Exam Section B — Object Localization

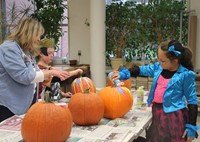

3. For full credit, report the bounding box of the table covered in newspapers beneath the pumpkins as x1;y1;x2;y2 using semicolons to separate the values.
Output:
0;90;152;142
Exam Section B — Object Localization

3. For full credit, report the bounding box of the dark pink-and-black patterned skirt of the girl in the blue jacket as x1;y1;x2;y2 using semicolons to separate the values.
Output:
147;103;188;142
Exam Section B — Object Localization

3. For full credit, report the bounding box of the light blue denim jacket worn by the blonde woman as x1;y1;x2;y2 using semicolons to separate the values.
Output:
0;41;38;115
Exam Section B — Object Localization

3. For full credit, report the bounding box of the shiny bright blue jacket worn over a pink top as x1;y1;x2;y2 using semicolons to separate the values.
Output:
139;63;198;113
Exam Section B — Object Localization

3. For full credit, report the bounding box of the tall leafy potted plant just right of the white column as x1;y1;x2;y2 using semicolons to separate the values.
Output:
106;2;137;68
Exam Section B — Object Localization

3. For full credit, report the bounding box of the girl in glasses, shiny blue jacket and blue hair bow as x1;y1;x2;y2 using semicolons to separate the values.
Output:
110;40;200;142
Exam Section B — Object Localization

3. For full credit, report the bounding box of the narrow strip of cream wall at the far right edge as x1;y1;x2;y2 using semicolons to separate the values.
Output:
189;0;200;70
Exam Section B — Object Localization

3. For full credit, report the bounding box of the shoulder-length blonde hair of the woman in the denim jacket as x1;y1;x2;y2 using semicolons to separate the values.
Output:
7;17;44;55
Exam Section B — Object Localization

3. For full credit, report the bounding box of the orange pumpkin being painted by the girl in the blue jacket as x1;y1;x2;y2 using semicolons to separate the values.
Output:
98;86;133;119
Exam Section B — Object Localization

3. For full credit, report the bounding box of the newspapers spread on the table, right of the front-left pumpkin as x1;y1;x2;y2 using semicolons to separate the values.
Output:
67;107;151;142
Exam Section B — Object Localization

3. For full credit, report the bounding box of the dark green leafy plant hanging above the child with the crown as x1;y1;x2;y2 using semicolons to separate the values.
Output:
31;0;67;50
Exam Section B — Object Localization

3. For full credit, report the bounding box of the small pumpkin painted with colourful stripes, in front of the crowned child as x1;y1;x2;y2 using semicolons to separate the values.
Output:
71;77;96;94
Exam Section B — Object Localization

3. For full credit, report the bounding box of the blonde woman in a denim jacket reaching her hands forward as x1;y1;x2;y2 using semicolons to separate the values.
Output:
0;17;69;122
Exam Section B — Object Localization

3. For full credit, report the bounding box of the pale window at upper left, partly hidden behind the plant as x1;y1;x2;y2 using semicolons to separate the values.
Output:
1;0;68;57
